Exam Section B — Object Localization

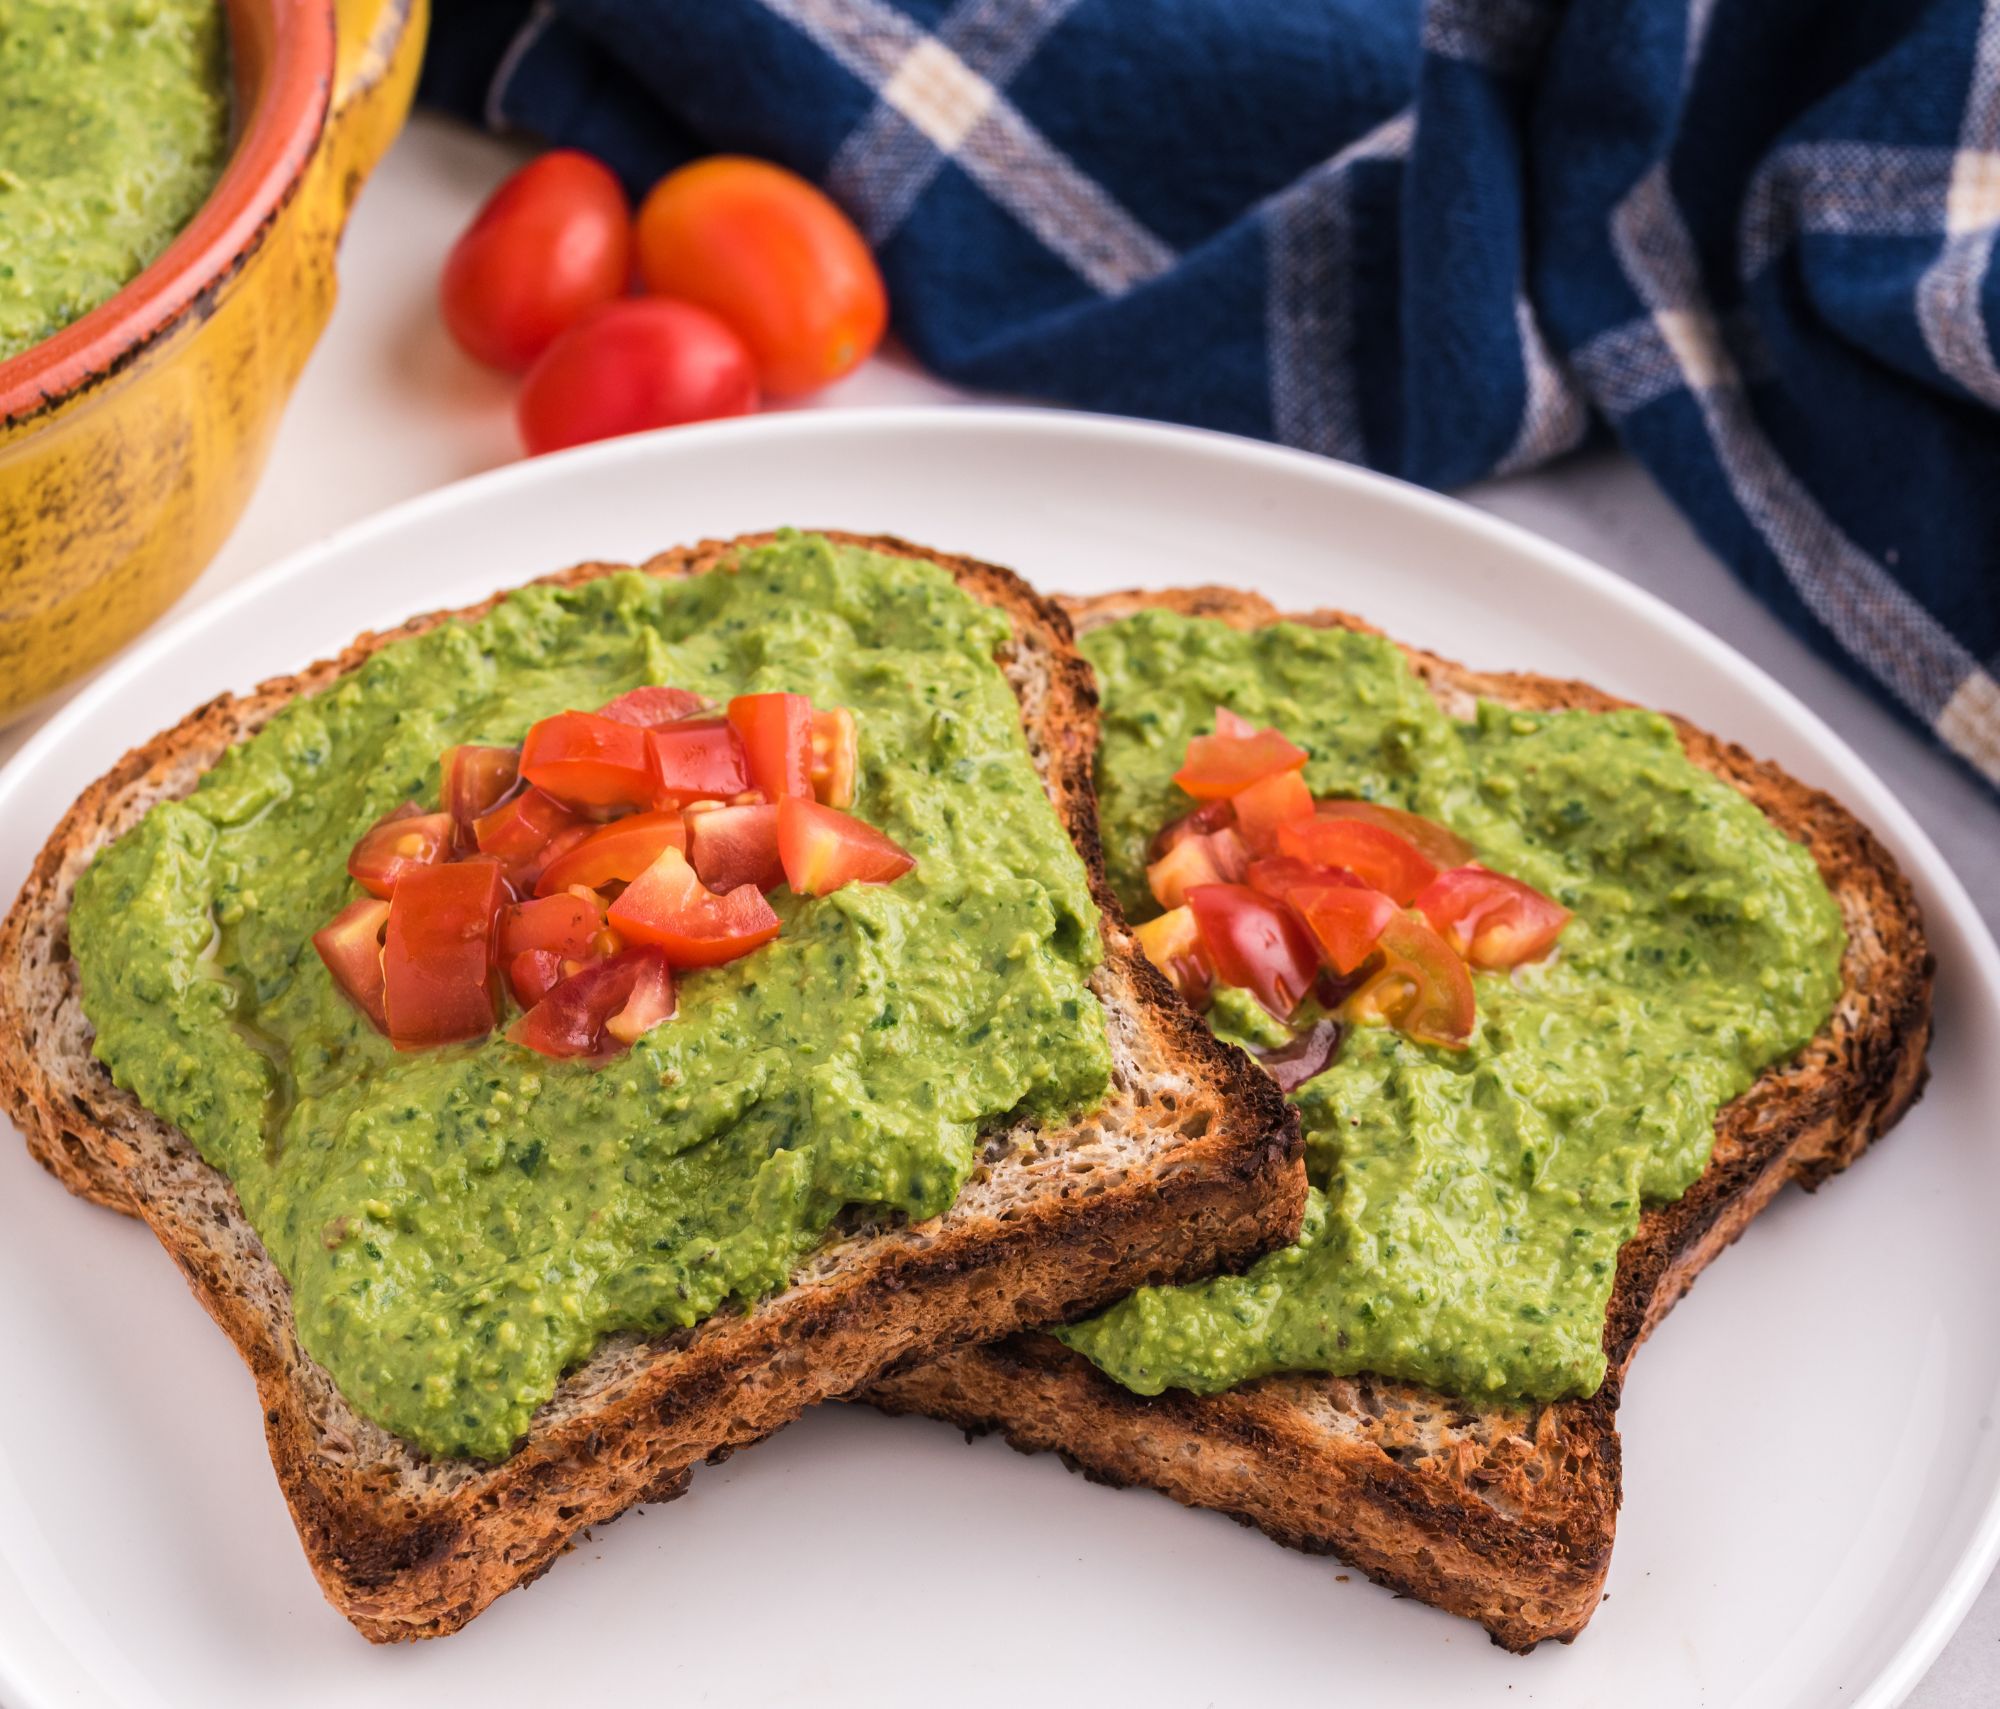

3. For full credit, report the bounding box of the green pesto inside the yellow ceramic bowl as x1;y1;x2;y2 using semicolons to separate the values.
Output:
0;0;230;360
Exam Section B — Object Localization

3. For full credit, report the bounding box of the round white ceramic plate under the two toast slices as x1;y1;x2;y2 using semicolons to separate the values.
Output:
0;410;2000;1709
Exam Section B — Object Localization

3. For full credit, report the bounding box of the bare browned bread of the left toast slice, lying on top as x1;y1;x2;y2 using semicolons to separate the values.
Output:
0;536;1304;1641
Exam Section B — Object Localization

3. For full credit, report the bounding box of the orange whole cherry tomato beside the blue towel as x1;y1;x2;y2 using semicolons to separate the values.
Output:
638;154;888;398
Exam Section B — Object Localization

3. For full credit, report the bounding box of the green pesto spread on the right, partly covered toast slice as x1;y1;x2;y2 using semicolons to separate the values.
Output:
1060;612;1846;1401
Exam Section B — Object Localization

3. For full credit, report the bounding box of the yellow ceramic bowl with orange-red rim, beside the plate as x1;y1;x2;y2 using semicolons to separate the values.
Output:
0;0;428;722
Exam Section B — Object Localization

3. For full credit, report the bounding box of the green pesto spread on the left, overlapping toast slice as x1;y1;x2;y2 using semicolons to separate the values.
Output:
70;538;1110;1459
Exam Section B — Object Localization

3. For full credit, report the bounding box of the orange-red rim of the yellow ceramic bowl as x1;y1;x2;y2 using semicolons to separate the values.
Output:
0;0;334;428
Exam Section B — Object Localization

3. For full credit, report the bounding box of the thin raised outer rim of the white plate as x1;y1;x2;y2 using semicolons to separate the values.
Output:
0;402;2000;1709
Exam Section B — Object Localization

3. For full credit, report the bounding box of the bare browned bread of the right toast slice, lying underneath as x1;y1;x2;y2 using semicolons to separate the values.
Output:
860;588;1932;1651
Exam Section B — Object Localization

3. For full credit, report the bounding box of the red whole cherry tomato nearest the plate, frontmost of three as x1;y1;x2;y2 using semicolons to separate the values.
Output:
514;296;758;456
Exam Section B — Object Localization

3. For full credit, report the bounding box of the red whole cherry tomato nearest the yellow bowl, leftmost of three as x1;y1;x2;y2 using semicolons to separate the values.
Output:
438;148;632;372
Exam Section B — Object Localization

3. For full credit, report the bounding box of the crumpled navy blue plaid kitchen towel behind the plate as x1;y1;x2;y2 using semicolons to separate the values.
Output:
426;0;2000;784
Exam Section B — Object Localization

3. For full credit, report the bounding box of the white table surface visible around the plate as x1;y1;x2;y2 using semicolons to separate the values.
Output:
0;116;2000;1709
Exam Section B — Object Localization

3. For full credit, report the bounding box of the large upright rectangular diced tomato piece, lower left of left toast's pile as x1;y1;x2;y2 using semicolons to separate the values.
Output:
382;861;506;1051
